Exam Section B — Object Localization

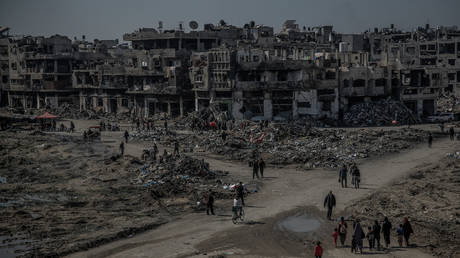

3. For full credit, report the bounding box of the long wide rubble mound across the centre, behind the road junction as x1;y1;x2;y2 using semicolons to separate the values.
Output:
168;121;426;168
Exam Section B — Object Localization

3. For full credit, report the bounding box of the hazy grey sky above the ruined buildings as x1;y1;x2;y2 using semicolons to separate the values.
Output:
0;0;460;39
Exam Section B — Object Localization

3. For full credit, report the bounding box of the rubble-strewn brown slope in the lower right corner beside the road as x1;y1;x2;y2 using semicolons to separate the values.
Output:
347;152;460;257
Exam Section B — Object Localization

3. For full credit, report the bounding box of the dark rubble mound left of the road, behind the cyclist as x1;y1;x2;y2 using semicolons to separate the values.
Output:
133;155;232;201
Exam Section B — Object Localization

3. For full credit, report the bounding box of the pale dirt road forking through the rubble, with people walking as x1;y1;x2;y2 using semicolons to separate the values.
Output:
65;127;454;257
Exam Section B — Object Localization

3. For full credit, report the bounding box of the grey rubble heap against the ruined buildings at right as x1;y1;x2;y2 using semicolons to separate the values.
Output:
343;99;420;126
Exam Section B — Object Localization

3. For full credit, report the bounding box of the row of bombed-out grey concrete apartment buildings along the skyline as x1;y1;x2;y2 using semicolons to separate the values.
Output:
0;20;460;120
